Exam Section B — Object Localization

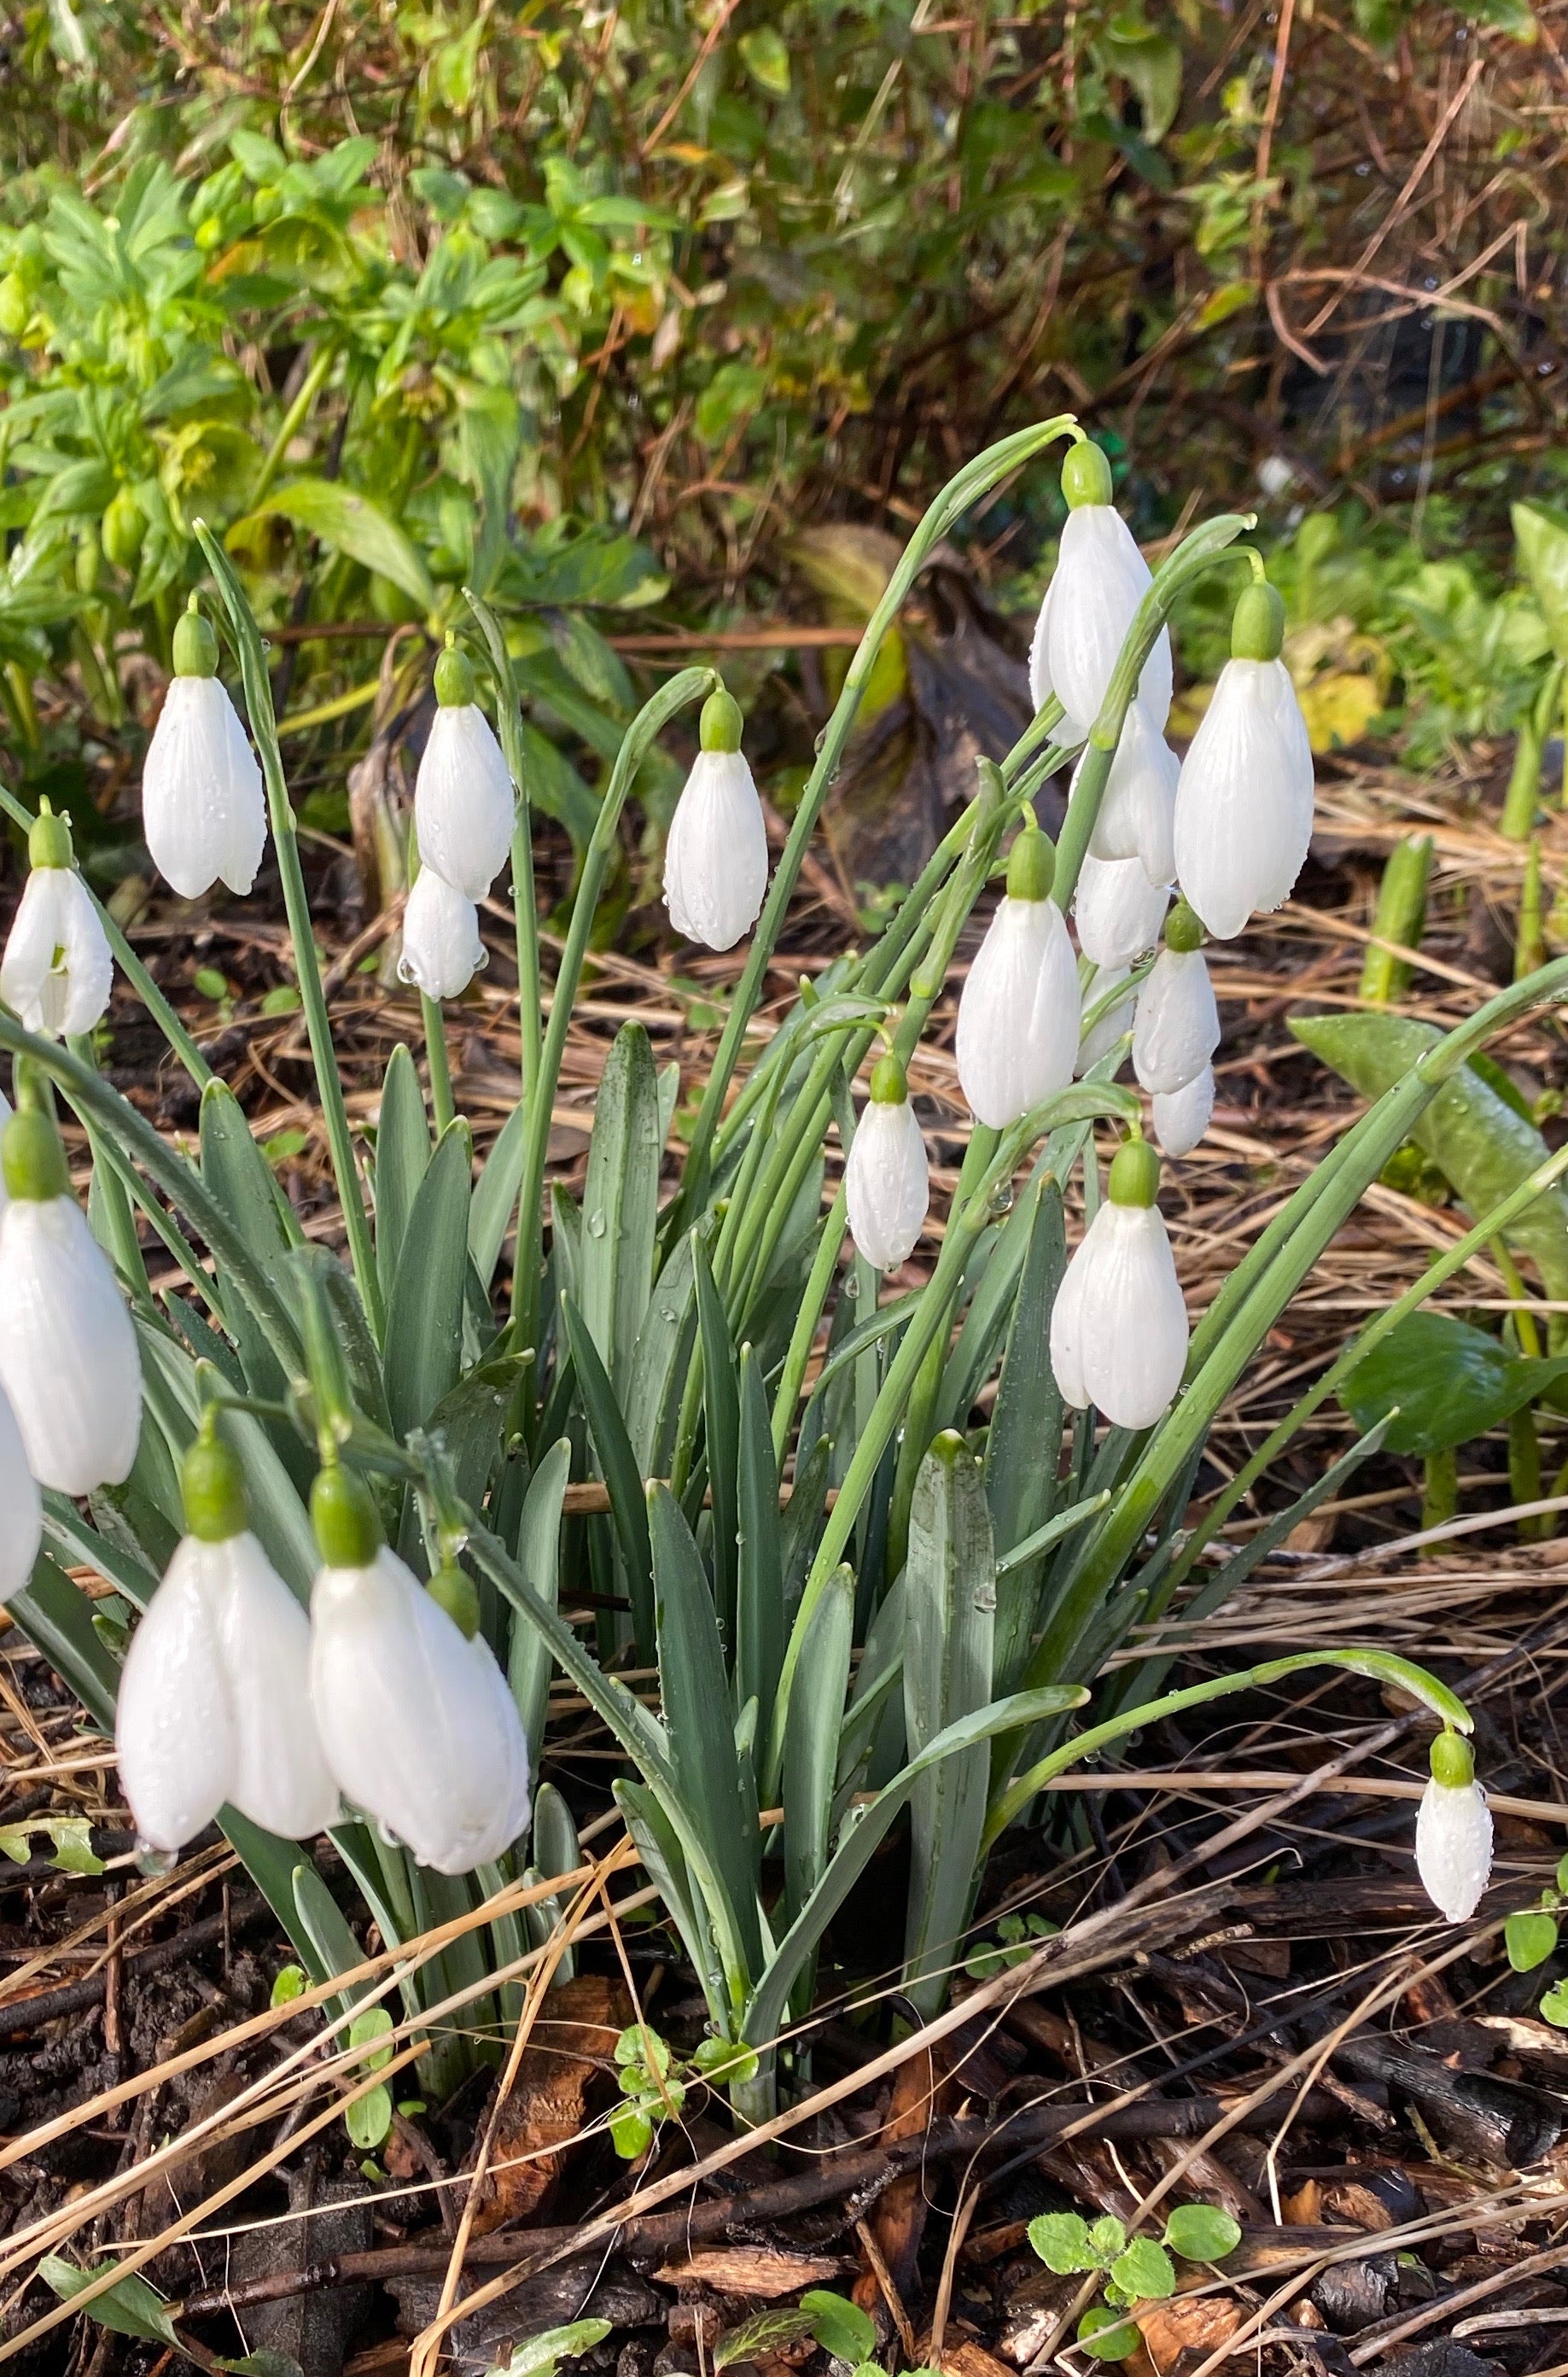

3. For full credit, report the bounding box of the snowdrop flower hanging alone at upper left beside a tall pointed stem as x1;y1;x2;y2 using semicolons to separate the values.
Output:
143;594;266;898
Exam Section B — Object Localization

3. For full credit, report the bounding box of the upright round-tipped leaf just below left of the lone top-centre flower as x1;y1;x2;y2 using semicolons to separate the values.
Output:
577;1022;663;1393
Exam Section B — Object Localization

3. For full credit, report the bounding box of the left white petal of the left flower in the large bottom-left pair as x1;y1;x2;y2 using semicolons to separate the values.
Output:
114;1538;236;1849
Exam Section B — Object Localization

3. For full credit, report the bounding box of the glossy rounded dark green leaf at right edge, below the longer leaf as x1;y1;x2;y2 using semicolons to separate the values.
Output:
1340;1312;1568;1455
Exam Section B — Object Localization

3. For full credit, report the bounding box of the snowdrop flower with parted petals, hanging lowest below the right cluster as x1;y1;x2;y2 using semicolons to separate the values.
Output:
1050;1139;1188;1428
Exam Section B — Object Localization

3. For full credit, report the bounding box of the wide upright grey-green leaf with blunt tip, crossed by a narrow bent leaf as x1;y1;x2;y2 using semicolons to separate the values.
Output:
898;1428;995;2013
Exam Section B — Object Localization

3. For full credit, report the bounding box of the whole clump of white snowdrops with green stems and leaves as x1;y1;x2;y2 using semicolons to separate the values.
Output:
0;416;1520;2116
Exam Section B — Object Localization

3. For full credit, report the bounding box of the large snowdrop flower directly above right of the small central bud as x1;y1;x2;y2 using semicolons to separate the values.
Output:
955;820;1081;1129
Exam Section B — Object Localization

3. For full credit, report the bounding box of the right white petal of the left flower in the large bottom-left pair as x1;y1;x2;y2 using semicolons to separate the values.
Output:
202;1533;337;1840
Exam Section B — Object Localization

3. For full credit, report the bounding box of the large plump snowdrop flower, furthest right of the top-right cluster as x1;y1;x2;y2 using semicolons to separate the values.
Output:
1176;580;1311;941
